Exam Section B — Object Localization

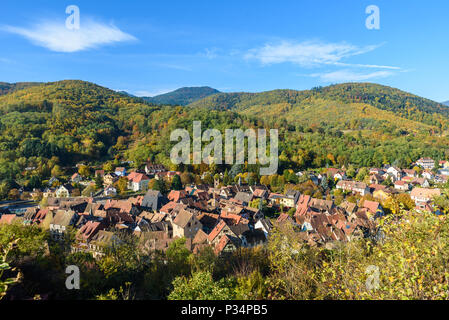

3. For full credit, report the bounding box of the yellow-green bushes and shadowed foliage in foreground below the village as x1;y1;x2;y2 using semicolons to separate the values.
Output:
0;211;449;300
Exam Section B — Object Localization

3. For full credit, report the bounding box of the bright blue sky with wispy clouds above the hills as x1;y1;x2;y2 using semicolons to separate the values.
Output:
0;0;449;101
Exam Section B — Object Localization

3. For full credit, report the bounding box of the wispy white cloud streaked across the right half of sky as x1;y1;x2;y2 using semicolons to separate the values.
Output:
245;41;398;69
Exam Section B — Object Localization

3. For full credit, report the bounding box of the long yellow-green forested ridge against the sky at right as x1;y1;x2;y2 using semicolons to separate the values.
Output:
190;83;449;128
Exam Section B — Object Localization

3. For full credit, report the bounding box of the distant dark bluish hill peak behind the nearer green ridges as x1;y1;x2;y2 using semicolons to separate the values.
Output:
143;87;220;106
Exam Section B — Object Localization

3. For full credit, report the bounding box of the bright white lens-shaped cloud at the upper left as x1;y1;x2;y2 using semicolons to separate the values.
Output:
2;19;136;52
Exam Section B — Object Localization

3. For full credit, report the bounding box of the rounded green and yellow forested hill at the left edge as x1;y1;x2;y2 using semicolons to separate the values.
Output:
0;80;160;168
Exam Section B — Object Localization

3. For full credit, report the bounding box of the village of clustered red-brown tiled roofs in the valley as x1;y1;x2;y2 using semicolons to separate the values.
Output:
0;158;449;258
